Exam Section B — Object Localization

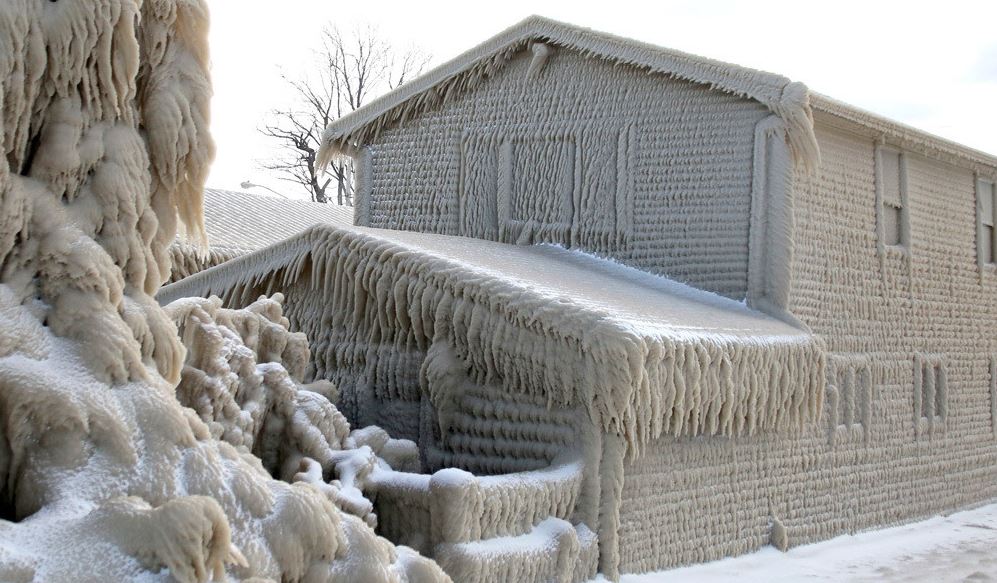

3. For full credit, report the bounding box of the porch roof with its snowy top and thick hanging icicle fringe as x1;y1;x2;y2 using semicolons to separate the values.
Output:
157;226;824;449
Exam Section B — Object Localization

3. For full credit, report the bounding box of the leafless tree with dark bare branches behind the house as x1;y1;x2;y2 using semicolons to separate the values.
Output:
260;26;430;204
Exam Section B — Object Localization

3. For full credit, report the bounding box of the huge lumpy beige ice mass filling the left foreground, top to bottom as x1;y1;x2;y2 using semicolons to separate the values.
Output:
0;0;445;581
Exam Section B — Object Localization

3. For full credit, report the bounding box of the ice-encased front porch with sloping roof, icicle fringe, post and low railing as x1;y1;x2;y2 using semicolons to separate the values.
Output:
159;222;824;581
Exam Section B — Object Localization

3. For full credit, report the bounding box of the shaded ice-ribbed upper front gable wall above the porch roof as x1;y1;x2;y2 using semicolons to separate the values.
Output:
346;42;770;298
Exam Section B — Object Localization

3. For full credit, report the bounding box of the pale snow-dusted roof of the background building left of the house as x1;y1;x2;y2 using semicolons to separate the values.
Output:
196;188;353;254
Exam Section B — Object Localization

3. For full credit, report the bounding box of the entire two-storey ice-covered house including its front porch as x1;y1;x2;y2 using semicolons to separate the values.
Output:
161;17;997;580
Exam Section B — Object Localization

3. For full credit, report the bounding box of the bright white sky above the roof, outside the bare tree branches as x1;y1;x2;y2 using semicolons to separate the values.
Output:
208;0;997;198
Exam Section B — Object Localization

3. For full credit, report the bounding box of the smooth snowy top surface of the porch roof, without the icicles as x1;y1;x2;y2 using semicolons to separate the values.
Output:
167;225;809;343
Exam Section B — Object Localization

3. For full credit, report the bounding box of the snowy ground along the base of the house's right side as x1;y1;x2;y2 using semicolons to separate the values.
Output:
622;504;997;583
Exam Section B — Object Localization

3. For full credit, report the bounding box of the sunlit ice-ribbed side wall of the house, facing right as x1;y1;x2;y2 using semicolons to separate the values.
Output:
620;117;997;571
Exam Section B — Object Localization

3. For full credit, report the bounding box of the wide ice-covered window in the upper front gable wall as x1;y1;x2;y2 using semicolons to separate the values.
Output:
458;126;636;252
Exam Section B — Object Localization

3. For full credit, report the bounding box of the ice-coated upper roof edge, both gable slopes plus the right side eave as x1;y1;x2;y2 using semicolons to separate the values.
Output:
319;16;997;174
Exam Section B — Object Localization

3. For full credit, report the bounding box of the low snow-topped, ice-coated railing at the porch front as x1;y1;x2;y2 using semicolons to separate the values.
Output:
366;452;597;581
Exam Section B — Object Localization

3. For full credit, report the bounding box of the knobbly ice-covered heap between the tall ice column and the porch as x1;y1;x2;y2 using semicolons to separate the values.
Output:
166;295;419;526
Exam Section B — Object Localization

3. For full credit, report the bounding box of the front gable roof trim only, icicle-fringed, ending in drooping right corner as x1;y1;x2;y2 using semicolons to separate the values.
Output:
319;16;819;169
